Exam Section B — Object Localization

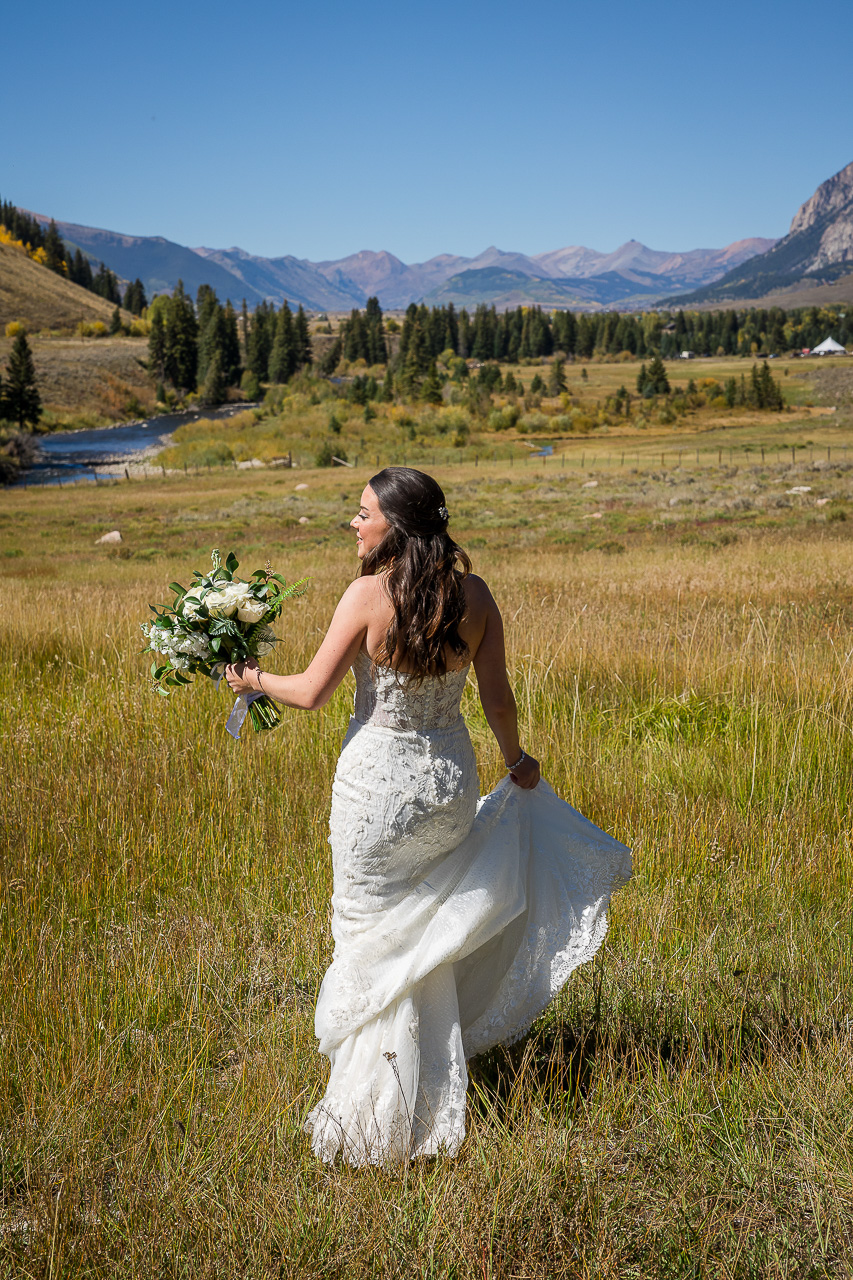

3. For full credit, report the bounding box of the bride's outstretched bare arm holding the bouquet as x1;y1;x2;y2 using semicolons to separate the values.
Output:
225;577;375;712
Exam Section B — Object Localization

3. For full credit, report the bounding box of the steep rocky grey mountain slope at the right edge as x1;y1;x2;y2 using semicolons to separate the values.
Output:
678;163;853;303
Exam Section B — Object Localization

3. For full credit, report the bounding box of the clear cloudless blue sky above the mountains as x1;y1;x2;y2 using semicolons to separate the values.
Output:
0;0;853;262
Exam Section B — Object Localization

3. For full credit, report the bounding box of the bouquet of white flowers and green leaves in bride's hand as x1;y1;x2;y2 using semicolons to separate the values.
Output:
142;550;306;737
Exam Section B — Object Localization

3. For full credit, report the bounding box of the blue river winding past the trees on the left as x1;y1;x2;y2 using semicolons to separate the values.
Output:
22;404;254;484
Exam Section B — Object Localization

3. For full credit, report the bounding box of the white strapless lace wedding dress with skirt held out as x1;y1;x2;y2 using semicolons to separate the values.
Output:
306;653;630;1165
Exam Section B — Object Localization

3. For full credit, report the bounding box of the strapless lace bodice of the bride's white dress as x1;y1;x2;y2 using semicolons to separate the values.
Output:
352;650;469;731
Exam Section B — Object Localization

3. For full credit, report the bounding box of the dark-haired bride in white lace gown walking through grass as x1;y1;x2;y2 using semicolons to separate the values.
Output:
227;467;630;1165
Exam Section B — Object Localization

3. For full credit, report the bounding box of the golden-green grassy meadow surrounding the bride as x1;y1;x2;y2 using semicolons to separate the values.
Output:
0;394;853;1280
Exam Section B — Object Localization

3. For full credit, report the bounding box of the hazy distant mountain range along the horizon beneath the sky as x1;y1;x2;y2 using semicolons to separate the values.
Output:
24;214;775;311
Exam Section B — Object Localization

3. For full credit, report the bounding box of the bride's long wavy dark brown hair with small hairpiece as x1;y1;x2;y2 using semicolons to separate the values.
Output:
361;467;471;682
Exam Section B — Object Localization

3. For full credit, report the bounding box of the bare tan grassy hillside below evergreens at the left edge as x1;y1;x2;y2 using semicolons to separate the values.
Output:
0;244;126;333
